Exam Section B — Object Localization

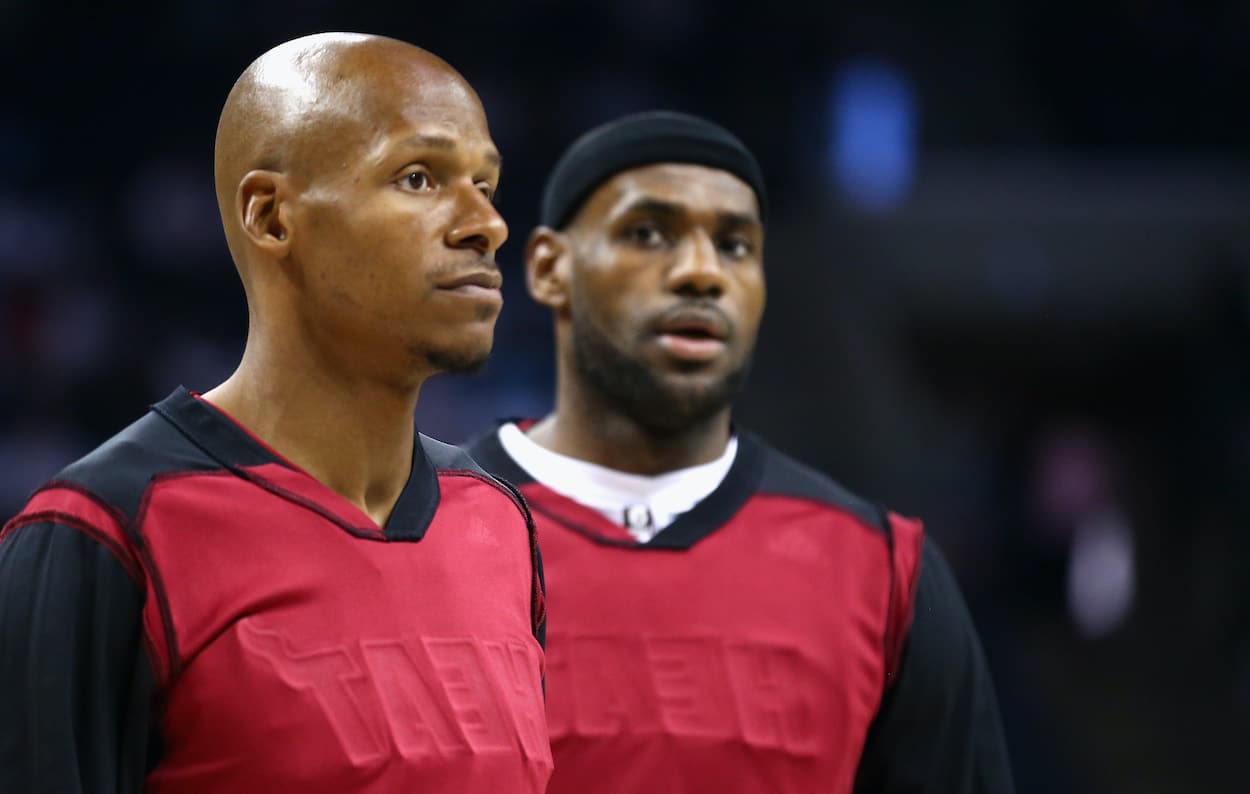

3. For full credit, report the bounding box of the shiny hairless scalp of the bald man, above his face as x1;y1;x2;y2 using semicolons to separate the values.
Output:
214;33;485;273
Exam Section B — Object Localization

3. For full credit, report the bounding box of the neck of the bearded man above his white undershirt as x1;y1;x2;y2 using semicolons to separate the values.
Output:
529;366;730;475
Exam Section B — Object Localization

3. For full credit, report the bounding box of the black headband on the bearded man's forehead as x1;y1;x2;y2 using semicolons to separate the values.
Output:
539;110;765;229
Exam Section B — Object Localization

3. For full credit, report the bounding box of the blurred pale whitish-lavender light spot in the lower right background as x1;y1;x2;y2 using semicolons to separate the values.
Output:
1068;510;1136;638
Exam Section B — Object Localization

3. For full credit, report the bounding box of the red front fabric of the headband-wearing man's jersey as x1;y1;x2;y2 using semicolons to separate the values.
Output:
521;483;919;794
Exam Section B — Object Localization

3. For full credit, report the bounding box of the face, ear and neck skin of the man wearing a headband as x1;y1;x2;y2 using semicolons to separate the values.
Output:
526;163;765;474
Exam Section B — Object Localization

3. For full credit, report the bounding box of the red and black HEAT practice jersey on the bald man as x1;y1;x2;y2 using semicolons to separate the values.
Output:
0;390;551;794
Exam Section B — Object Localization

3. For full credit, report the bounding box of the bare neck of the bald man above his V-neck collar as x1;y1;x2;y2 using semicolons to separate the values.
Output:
204;335;420;526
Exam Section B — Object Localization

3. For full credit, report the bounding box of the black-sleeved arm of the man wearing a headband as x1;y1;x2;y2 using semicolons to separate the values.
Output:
855;540;1014;794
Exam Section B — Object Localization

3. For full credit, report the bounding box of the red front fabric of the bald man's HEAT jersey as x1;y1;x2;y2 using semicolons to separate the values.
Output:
24;464;551;794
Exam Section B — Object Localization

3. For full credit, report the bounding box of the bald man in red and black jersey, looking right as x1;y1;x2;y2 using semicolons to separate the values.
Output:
0;34;551;794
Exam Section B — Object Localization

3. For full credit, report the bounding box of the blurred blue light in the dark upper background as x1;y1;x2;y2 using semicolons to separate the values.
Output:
829;60;916;211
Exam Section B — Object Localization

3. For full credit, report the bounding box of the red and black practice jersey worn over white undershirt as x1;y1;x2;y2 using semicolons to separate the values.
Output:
470;433;1011;794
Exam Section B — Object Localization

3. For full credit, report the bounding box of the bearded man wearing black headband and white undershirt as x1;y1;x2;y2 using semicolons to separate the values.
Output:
470;113;1013;794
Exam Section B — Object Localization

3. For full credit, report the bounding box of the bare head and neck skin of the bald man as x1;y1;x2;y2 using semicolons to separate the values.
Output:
205;34;508;525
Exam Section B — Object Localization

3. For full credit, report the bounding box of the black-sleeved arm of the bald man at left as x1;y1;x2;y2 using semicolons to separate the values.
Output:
0;521;154;794
